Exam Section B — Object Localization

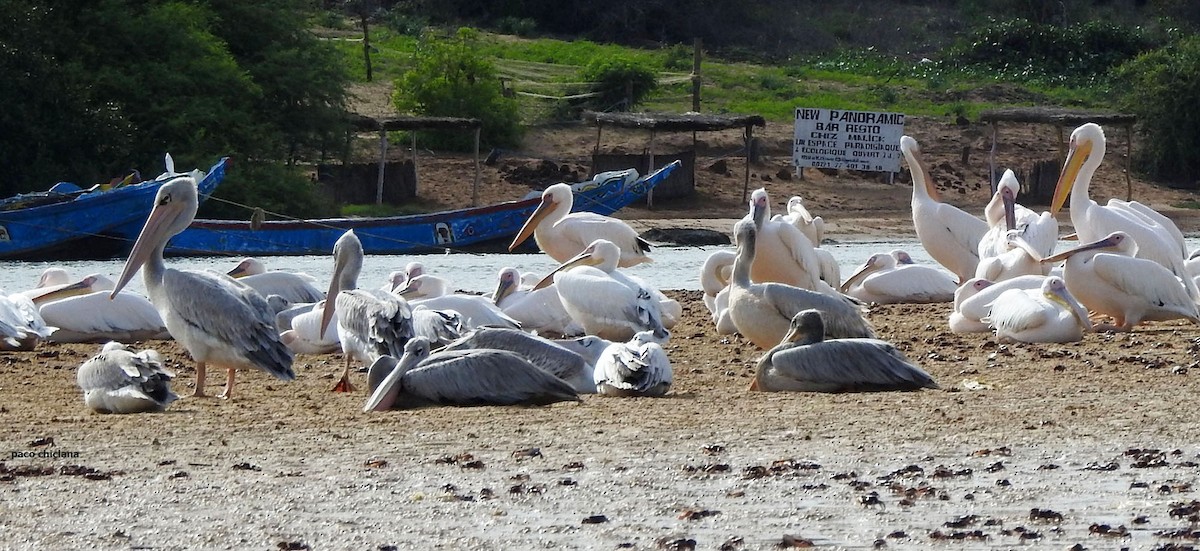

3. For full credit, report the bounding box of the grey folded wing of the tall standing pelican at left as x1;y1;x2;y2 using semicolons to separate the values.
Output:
160;270;295;381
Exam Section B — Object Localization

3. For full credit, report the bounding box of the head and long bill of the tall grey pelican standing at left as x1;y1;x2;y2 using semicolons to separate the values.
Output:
109;175;199;298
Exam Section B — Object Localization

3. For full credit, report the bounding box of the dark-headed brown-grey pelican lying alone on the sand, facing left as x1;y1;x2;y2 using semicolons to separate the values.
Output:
750;310;937;393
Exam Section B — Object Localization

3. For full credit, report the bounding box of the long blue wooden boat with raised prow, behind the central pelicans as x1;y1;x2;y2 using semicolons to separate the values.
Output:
166;161;679;256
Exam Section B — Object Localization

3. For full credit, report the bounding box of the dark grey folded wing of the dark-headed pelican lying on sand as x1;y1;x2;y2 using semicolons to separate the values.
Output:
758;339;937;393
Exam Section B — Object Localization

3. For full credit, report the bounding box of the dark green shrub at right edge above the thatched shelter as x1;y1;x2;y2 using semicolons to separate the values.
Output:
1116;36;1200;187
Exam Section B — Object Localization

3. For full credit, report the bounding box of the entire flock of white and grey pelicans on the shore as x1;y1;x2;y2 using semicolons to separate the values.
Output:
0;124;1200;413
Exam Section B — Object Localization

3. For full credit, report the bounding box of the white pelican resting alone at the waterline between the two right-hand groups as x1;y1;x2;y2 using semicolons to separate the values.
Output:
841;252;958;304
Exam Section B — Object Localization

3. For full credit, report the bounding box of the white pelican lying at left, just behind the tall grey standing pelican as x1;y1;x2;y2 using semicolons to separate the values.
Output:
31;274;170;342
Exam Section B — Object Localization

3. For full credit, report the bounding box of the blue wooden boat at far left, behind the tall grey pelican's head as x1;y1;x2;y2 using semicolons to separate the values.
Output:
0;154;227;260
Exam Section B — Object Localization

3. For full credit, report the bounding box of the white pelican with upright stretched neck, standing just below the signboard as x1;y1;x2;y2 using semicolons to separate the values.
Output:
900;136;988;282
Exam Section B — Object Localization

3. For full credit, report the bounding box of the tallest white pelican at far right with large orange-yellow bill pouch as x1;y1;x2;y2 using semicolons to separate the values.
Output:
1050;122;1200;304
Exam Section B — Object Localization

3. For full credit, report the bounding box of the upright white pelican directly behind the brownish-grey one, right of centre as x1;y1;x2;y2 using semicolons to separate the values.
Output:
734;187;836;294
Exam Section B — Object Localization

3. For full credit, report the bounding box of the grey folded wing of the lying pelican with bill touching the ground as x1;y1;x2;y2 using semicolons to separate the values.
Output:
403;349;578;406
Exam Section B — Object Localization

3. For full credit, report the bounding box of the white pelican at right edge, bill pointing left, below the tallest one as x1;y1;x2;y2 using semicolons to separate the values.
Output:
1046;232;1200;331
